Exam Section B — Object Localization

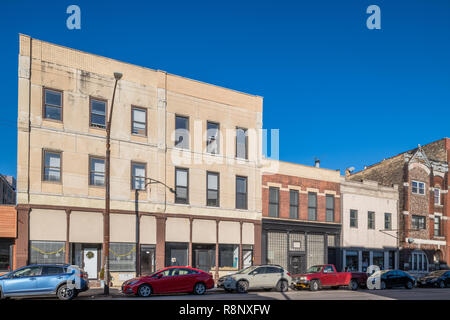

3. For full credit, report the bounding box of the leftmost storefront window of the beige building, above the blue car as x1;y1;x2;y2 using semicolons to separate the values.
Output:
30;241;66;264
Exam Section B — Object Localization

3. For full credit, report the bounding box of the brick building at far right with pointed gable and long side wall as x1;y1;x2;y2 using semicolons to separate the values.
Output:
348;138;450;274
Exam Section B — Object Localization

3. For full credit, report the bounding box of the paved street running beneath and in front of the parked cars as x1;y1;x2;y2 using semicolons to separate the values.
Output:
67;288;450;300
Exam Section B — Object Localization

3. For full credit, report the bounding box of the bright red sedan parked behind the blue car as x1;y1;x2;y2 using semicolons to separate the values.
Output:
122;267;214;297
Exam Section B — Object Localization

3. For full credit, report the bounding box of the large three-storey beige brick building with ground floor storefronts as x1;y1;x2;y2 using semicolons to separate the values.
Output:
16;35;262;284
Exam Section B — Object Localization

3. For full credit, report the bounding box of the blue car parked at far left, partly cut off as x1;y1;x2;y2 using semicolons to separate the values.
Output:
0;264;89;300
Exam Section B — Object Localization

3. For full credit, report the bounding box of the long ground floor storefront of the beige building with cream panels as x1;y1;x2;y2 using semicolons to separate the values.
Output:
17;206;261;285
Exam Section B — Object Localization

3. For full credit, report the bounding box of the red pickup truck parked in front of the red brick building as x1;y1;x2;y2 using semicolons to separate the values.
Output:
292;264;367;291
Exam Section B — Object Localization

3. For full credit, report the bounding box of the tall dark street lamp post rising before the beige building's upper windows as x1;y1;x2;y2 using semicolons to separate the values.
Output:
103;72;122;295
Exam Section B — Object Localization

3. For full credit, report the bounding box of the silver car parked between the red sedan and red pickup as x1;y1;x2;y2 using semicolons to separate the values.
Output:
219;265;292;293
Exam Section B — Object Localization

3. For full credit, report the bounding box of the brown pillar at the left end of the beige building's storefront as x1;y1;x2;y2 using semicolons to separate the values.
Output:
15;208;31;268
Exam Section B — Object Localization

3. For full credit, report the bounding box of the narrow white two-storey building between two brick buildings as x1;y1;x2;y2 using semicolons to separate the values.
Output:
341;177;399;272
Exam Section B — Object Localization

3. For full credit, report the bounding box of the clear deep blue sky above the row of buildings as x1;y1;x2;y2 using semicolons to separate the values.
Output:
0;0;450;175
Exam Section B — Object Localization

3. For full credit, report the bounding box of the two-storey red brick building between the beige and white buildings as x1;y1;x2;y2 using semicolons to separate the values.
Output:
262;161;341;274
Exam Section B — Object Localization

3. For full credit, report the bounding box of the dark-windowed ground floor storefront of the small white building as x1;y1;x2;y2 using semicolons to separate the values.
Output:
341;247;399;272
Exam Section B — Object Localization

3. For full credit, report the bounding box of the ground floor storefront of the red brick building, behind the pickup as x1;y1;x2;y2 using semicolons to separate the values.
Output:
262;219;341;274
